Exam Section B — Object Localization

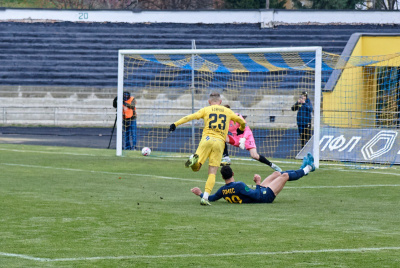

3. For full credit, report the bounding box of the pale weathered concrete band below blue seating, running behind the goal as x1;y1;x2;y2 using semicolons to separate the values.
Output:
0;93;296;128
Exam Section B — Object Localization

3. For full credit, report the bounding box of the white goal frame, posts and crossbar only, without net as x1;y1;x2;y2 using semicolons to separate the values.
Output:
116;46;322;168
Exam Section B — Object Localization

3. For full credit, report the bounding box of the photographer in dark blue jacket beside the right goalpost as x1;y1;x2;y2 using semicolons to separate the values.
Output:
292;91;313;147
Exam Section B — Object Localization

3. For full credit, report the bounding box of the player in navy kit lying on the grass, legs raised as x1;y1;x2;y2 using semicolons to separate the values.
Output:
191;153;315;204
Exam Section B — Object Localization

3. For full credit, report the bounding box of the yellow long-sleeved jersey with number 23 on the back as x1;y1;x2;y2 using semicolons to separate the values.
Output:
174;105;246;142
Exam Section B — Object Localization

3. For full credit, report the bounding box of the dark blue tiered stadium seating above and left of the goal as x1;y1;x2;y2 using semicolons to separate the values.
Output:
0;22;400;124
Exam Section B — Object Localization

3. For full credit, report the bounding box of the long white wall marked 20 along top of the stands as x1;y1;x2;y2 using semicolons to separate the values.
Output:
0;8;400;27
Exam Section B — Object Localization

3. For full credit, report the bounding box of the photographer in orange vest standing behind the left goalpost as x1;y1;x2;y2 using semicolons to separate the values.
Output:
113;91;136;150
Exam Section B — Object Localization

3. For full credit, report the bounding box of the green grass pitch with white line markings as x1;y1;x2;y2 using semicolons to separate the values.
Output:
0;144;400;267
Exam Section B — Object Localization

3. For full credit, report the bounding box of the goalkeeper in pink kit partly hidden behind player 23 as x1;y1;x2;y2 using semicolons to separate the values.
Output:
221;105;282;172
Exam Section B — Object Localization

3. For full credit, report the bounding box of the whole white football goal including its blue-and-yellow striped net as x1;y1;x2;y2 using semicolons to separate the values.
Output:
116;47;322;167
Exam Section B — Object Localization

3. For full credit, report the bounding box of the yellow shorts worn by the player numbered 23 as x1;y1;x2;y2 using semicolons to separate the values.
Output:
196;136;225;167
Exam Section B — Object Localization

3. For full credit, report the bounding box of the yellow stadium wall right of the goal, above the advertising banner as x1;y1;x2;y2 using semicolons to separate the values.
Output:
323;33;400;128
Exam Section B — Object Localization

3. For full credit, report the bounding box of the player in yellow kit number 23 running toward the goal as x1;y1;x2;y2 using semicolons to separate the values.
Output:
169;92;246;206
